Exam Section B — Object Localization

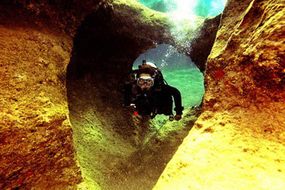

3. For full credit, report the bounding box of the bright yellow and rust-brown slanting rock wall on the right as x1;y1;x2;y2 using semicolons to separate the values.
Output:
154;0;285;189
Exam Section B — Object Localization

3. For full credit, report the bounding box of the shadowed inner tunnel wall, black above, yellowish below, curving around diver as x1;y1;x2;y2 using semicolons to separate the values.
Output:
67;5;204;189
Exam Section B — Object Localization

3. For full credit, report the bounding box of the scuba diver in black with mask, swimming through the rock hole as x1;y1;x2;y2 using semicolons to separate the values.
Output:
124;60;183;121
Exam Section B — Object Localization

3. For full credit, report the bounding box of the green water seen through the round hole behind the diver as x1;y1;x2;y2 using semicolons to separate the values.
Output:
133;44;205;108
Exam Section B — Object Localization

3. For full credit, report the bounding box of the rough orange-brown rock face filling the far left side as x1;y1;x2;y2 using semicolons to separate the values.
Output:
0;26;80;189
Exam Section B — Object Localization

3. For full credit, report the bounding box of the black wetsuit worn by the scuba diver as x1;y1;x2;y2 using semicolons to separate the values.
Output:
124;70;183;116
